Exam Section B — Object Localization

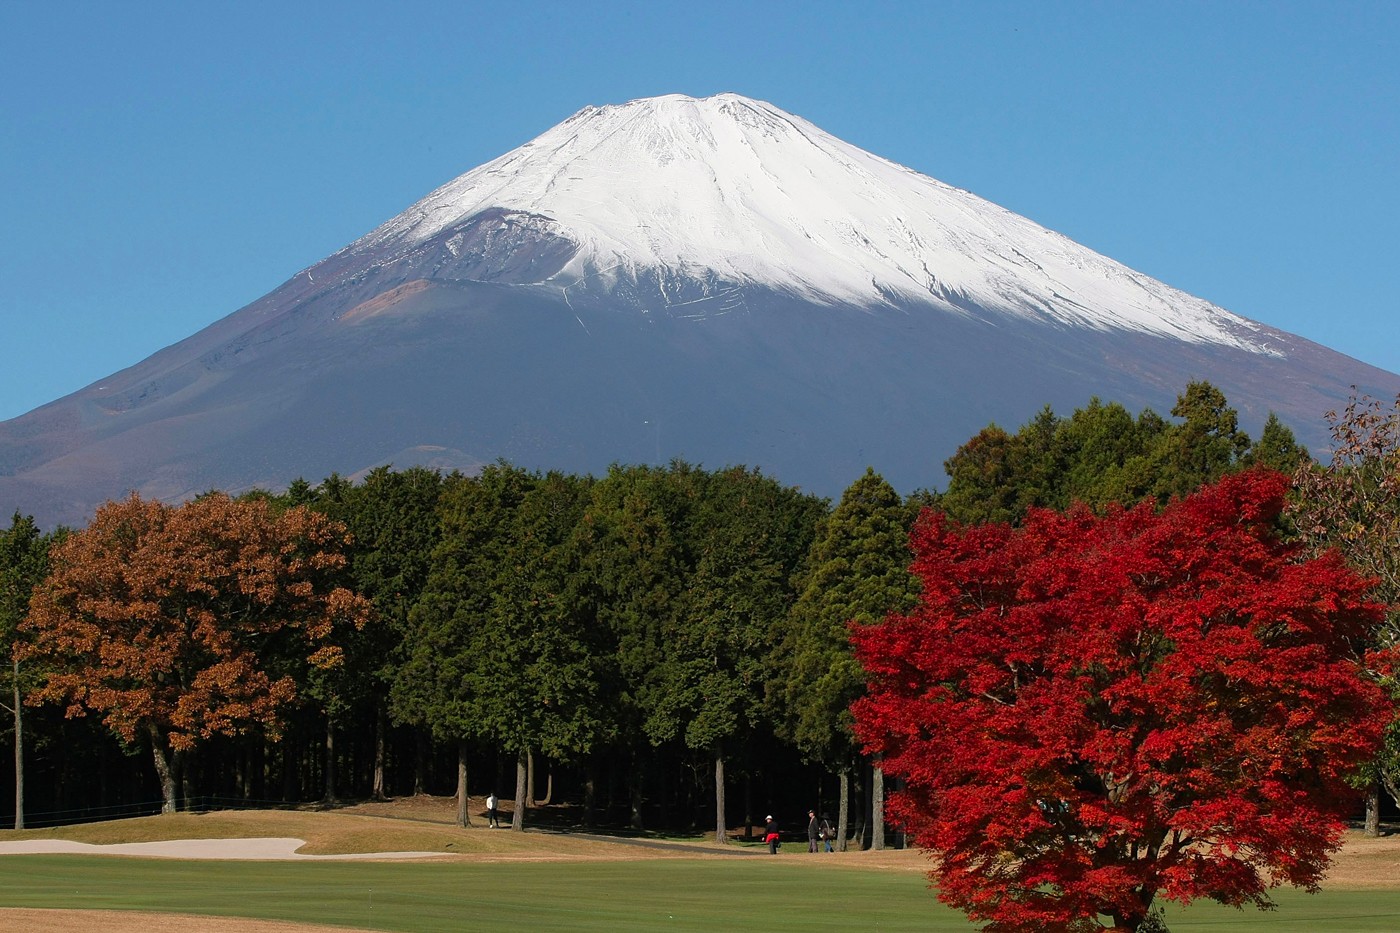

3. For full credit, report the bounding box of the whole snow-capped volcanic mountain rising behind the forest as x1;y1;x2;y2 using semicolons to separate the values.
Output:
0;94;1400;525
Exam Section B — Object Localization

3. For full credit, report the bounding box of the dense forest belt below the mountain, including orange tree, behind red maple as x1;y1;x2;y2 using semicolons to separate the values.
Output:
0;382;1383;846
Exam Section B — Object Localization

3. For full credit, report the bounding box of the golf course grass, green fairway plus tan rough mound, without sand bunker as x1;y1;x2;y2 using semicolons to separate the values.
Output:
0;797;1400;933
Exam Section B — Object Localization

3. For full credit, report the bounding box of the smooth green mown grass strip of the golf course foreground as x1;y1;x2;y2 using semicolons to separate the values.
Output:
0;855;1400;933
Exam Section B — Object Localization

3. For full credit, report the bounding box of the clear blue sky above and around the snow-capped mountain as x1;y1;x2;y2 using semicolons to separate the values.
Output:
0;0;1400;419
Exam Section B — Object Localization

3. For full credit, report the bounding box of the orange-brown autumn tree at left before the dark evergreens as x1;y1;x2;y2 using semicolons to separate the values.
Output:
22;493;371;813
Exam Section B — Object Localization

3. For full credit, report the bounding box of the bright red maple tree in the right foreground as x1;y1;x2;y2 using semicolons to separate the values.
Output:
851;471;1392;933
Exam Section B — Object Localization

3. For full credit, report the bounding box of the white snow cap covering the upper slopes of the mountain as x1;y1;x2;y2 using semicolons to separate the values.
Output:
344;94;1277;353
